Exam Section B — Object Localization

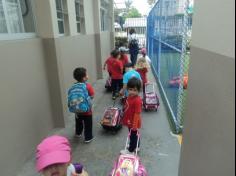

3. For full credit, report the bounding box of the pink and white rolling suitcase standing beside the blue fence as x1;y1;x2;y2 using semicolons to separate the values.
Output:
143;83;160;111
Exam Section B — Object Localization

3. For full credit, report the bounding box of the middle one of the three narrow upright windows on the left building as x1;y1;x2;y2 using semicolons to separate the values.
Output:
75;0;85;33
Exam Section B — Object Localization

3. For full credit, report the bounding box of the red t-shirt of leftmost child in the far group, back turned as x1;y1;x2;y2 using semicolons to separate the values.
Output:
110;58;123;79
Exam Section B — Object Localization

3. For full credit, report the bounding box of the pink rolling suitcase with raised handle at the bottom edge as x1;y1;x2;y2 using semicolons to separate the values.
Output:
109;130;148;176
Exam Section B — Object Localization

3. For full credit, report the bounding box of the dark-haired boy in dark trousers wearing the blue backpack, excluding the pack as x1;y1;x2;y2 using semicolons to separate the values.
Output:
73;67;94;143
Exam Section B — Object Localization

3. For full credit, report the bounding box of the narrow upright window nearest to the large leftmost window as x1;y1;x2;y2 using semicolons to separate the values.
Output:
56;0;68;34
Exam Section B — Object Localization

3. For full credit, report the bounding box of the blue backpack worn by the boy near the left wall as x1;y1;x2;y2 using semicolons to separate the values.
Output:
68;83;92;113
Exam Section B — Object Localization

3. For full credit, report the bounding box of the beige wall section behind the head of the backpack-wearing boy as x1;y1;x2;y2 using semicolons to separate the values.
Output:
56;35;97;88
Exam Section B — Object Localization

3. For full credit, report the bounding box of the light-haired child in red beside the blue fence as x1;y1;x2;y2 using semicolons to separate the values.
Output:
136;53;149;92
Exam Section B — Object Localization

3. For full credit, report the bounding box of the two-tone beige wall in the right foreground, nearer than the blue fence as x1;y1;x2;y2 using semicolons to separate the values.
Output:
179;0;235;176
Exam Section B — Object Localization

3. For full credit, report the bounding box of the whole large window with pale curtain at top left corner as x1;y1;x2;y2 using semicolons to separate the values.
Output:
0;0;35;35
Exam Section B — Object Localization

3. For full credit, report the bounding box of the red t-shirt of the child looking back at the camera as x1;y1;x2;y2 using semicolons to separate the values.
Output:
123;96;142;128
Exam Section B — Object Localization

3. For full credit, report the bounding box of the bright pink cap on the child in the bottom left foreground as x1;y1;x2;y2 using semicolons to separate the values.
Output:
36;136;71;172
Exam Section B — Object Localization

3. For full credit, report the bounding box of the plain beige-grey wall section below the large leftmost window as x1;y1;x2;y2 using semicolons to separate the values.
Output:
0;39;54;175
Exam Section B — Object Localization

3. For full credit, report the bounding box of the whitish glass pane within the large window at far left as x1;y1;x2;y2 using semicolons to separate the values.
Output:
6;0;24;33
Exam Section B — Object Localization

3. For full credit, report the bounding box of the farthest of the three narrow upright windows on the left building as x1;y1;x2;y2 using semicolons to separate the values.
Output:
100;0;111;31
